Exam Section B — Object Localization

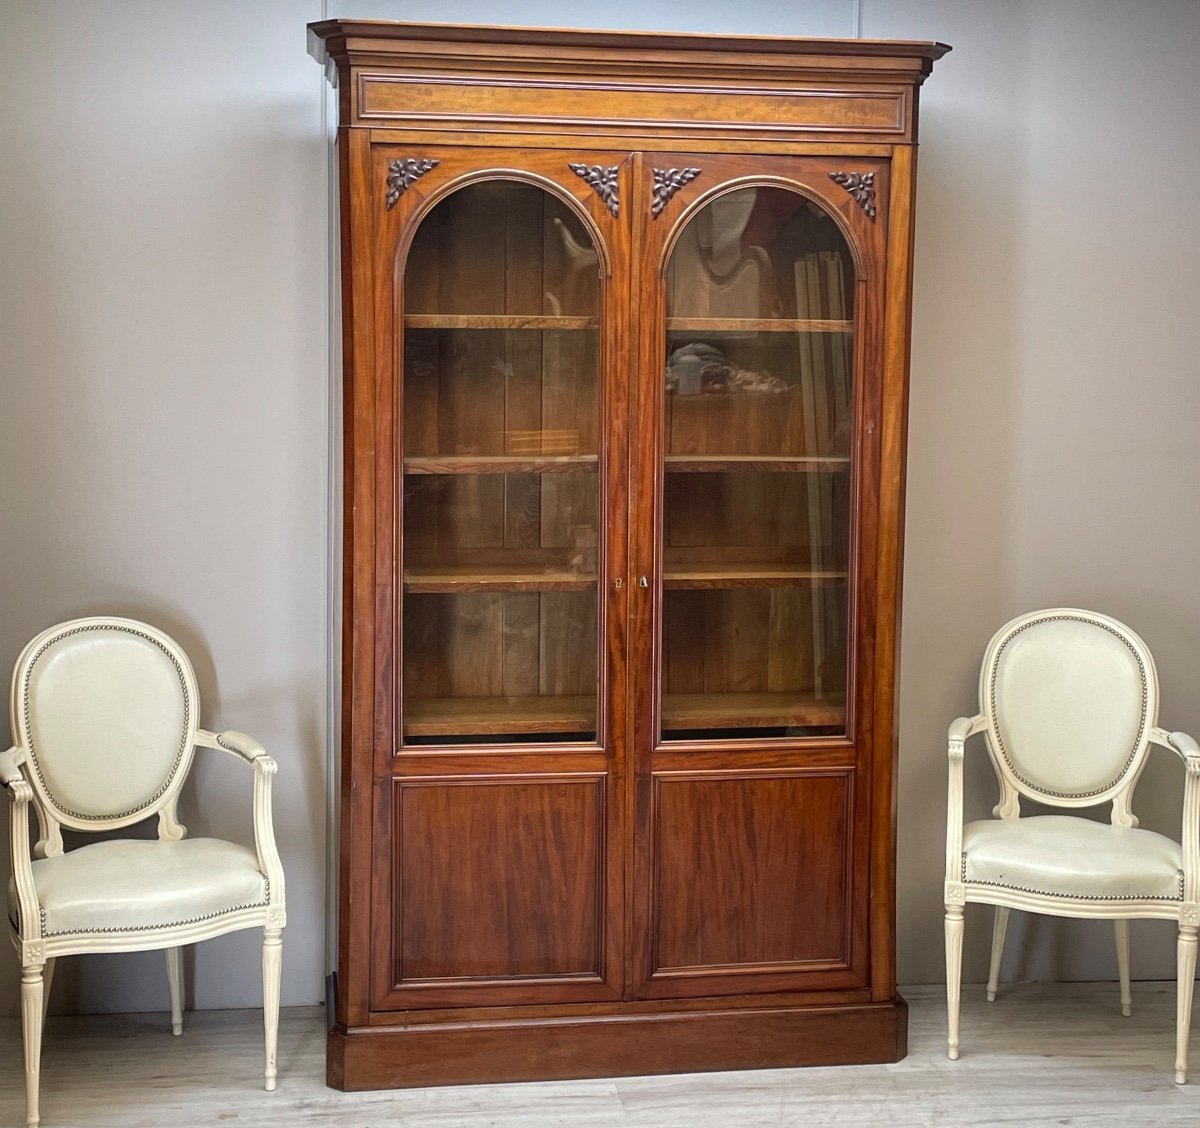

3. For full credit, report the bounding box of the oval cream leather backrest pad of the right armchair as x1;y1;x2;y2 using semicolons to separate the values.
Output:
980;611;1154;798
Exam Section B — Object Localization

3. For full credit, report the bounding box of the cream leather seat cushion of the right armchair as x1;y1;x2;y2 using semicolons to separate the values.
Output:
962;815;1183;901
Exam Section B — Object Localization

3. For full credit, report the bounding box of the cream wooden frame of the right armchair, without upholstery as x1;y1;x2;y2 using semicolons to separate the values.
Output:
944;607;1200;1085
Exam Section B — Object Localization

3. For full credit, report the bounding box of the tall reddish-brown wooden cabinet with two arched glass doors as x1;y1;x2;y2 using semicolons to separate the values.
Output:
310;20;947;1088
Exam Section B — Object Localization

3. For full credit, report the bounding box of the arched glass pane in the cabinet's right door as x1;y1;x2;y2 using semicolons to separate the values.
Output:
661;186;854;740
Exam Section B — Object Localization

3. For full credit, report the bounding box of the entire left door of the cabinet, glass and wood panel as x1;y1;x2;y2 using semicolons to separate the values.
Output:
372;145;628;1010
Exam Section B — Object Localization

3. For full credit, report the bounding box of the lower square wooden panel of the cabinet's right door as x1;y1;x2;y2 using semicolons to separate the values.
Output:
643;769;857;997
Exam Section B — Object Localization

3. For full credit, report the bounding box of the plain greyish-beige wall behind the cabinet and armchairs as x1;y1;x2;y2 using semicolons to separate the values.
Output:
0;0;1200;1010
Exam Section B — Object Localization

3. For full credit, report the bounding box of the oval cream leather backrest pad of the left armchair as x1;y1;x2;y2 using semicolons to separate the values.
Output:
14;620;197;826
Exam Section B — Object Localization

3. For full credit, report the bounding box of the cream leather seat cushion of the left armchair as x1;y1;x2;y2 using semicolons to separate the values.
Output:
8;838;268;936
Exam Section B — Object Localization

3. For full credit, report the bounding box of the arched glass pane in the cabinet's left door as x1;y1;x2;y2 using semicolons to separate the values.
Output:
402;180;600;744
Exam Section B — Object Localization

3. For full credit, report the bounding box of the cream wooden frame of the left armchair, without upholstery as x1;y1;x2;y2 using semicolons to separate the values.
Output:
0;617;287;1126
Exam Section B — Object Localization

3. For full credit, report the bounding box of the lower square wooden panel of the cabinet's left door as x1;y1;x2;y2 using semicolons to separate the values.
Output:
383;775;613;1006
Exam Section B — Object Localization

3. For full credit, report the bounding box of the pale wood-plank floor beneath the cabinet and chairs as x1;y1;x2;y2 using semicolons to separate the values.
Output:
0;983;1200;1128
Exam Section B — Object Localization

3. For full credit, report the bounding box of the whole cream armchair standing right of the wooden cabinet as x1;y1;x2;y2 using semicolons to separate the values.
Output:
946;607;1200;1085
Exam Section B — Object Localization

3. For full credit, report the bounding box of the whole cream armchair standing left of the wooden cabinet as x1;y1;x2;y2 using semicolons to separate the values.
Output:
0;618;284;1124
